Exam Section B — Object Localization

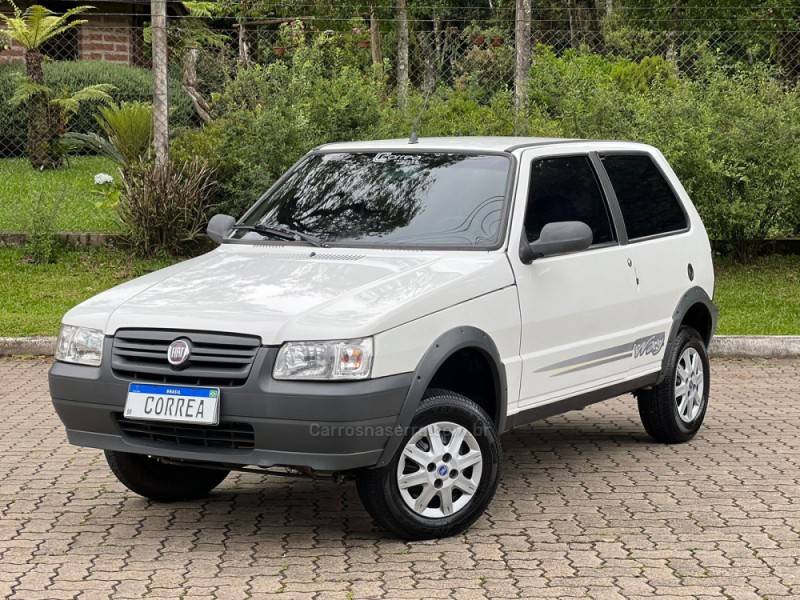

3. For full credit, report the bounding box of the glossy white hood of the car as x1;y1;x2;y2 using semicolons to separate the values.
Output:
64;244;514;344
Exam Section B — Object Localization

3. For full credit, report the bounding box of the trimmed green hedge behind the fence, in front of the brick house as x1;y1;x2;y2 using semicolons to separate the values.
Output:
0;60;195;156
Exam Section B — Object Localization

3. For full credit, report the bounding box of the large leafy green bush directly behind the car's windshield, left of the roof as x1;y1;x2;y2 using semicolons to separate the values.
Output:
173;35;384;215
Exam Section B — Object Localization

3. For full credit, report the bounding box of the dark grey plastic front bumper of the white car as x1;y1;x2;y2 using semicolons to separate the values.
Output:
49;344;412;471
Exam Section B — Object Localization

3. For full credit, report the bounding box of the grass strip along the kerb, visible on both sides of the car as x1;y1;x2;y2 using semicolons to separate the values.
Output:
0;248;800;337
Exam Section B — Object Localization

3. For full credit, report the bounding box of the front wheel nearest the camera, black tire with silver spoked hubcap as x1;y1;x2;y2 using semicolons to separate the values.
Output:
356;390;502;540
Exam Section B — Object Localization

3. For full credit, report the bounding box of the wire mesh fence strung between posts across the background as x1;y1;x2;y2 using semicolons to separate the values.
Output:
0;15;800;157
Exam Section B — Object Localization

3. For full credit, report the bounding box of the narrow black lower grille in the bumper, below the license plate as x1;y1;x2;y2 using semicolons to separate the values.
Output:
116;414;255;450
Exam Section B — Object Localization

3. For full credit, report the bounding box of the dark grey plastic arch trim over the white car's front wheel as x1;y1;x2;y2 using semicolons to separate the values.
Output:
375;326;508;467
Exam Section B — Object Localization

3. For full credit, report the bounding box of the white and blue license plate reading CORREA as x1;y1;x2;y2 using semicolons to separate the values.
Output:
125;383;219;425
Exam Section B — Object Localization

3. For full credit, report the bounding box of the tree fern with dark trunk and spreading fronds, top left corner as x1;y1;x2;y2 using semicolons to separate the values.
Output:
0;1;93;169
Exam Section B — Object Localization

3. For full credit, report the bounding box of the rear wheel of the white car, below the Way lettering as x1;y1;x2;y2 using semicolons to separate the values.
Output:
636;326;711;444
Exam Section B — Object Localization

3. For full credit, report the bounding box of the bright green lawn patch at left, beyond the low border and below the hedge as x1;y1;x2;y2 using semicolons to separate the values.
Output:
0;156;119;232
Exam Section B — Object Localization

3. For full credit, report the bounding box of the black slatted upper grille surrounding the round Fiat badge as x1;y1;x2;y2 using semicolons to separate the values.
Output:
111;329;261;386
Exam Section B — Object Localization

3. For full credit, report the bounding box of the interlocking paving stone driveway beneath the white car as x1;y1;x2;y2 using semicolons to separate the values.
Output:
0;360;800;599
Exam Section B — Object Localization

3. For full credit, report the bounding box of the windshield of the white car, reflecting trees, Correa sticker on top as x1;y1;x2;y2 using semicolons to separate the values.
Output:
235;152;511;248
